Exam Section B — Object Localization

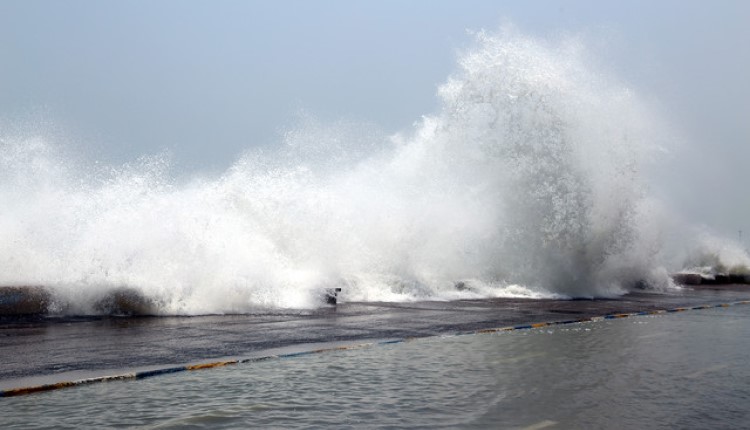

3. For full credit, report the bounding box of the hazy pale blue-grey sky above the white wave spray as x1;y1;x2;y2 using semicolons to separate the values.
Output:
0;0;750;236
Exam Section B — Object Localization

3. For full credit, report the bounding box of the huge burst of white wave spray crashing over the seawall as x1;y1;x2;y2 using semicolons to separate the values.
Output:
0;32;748;314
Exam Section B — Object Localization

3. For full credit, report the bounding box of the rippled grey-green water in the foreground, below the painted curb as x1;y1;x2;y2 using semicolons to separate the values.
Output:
0;305;750;429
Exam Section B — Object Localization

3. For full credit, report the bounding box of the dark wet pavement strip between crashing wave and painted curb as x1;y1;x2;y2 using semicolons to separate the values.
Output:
0;285;750;389
